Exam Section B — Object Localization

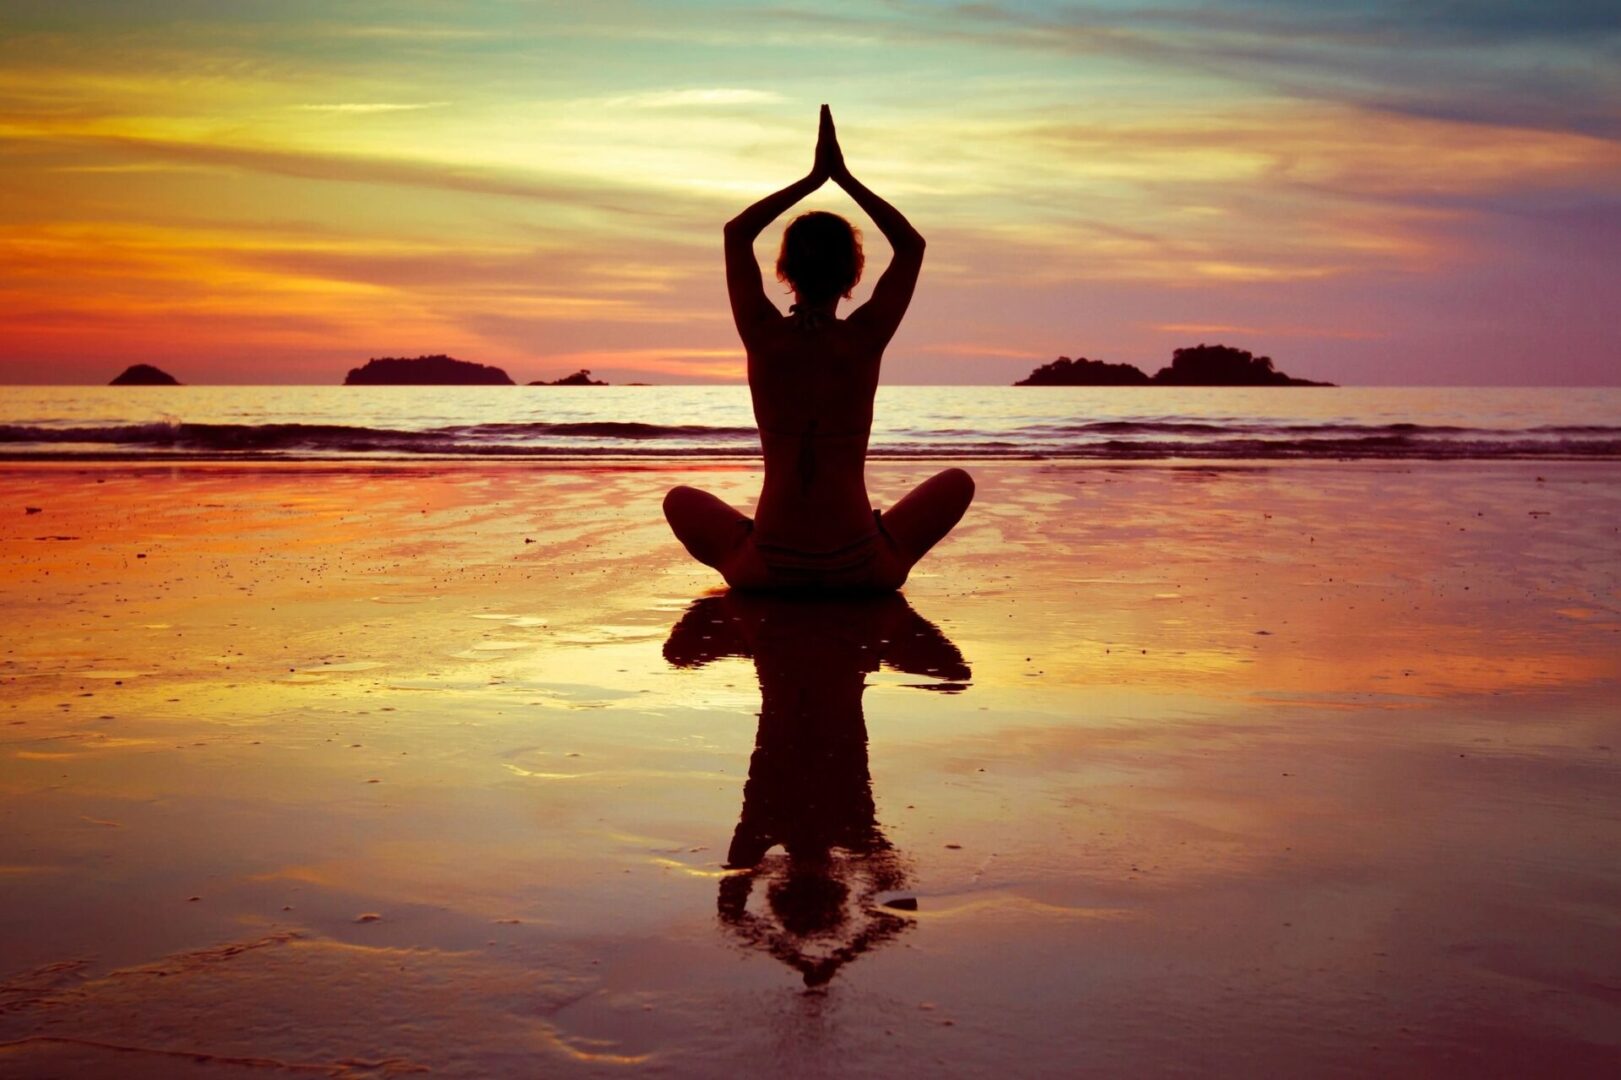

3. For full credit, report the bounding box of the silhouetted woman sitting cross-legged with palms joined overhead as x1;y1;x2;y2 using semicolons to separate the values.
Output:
665;105;974;590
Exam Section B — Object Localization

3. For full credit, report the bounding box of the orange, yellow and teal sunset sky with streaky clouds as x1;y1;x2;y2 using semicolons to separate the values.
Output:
0;0;1621;384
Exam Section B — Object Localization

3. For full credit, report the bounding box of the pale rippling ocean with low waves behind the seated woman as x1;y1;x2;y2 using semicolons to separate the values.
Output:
0;386;1621;461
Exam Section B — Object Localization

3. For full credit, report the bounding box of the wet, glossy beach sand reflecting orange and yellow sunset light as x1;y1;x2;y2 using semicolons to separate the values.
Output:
0;462;1621;1077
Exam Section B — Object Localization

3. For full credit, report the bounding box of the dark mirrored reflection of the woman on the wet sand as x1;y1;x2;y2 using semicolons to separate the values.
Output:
665;594;969;988
